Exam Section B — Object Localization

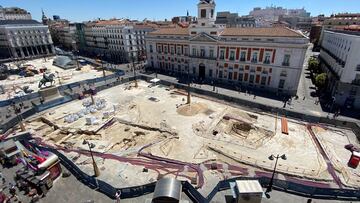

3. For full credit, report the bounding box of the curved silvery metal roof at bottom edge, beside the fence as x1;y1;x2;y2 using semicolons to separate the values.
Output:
153;178;182;201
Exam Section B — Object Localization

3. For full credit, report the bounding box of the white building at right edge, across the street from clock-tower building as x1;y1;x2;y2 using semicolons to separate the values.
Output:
320;30;360;109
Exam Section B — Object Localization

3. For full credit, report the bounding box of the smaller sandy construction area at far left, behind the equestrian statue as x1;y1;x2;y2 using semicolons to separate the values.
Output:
0;57;110;101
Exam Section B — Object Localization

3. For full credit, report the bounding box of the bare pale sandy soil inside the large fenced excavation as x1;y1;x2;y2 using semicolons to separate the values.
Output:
23;81;360;186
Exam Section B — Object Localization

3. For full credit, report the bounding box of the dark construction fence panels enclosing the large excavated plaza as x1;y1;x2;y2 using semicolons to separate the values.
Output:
0;73;360;203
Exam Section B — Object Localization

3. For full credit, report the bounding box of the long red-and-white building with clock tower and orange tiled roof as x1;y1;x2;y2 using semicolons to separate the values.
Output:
146;0;309;95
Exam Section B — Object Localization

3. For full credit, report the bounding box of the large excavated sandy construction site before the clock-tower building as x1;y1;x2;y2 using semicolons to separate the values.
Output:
17;81;360;193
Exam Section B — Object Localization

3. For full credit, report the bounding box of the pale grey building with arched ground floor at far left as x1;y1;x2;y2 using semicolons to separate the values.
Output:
0;20;54;59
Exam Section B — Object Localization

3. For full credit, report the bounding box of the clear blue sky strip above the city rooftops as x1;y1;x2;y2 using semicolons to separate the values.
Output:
0;0;360;21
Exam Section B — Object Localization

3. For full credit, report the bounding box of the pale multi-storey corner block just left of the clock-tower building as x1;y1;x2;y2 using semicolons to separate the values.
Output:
85;20;154;62
